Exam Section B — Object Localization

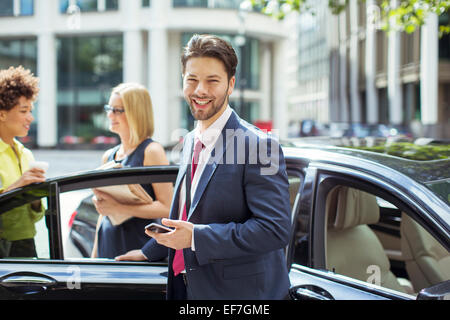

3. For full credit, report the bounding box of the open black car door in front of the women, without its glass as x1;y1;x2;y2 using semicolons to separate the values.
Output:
0;165;178;299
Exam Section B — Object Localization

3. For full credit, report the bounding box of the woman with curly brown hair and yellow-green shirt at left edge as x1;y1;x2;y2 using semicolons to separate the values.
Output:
0;66;45;258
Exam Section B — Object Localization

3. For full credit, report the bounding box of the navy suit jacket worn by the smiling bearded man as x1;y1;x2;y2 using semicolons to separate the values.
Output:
143;112;291;299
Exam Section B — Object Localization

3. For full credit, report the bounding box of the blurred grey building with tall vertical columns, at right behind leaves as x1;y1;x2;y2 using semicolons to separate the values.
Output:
288;0;450;139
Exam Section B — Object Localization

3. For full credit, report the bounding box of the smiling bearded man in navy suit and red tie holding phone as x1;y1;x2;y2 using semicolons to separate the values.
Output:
116;35;290;299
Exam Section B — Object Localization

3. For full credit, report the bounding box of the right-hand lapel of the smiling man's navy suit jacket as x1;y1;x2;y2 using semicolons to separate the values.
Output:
188;111;239;220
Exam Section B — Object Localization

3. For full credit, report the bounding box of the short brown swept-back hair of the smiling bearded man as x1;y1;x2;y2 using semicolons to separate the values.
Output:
181;34;238;80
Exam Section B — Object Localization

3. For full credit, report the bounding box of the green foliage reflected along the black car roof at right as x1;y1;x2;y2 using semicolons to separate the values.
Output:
351;142;450;161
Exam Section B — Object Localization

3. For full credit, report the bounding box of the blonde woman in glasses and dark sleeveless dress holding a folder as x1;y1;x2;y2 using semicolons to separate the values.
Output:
92;83;173;259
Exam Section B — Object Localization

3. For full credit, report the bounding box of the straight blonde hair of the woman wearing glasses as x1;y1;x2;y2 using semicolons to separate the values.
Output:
111;83;155;145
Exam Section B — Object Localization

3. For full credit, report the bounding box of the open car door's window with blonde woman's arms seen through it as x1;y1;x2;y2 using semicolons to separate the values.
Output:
60;175;173;261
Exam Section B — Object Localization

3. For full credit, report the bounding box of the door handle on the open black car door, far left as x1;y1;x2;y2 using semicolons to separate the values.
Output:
0;271;58;294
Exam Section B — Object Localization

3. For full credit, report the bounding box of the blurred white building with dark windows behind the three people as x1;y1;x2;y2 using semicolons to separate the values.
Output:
0;0;287;147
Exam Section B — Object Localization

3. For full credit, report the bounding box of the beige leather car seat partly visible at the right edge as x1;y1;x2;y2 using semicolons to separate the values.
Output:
400;213;450;292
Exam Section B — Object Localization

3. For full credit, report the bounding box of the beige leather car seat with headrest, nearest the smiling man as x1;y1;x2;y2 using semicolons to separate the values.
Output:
326;186;406;292
